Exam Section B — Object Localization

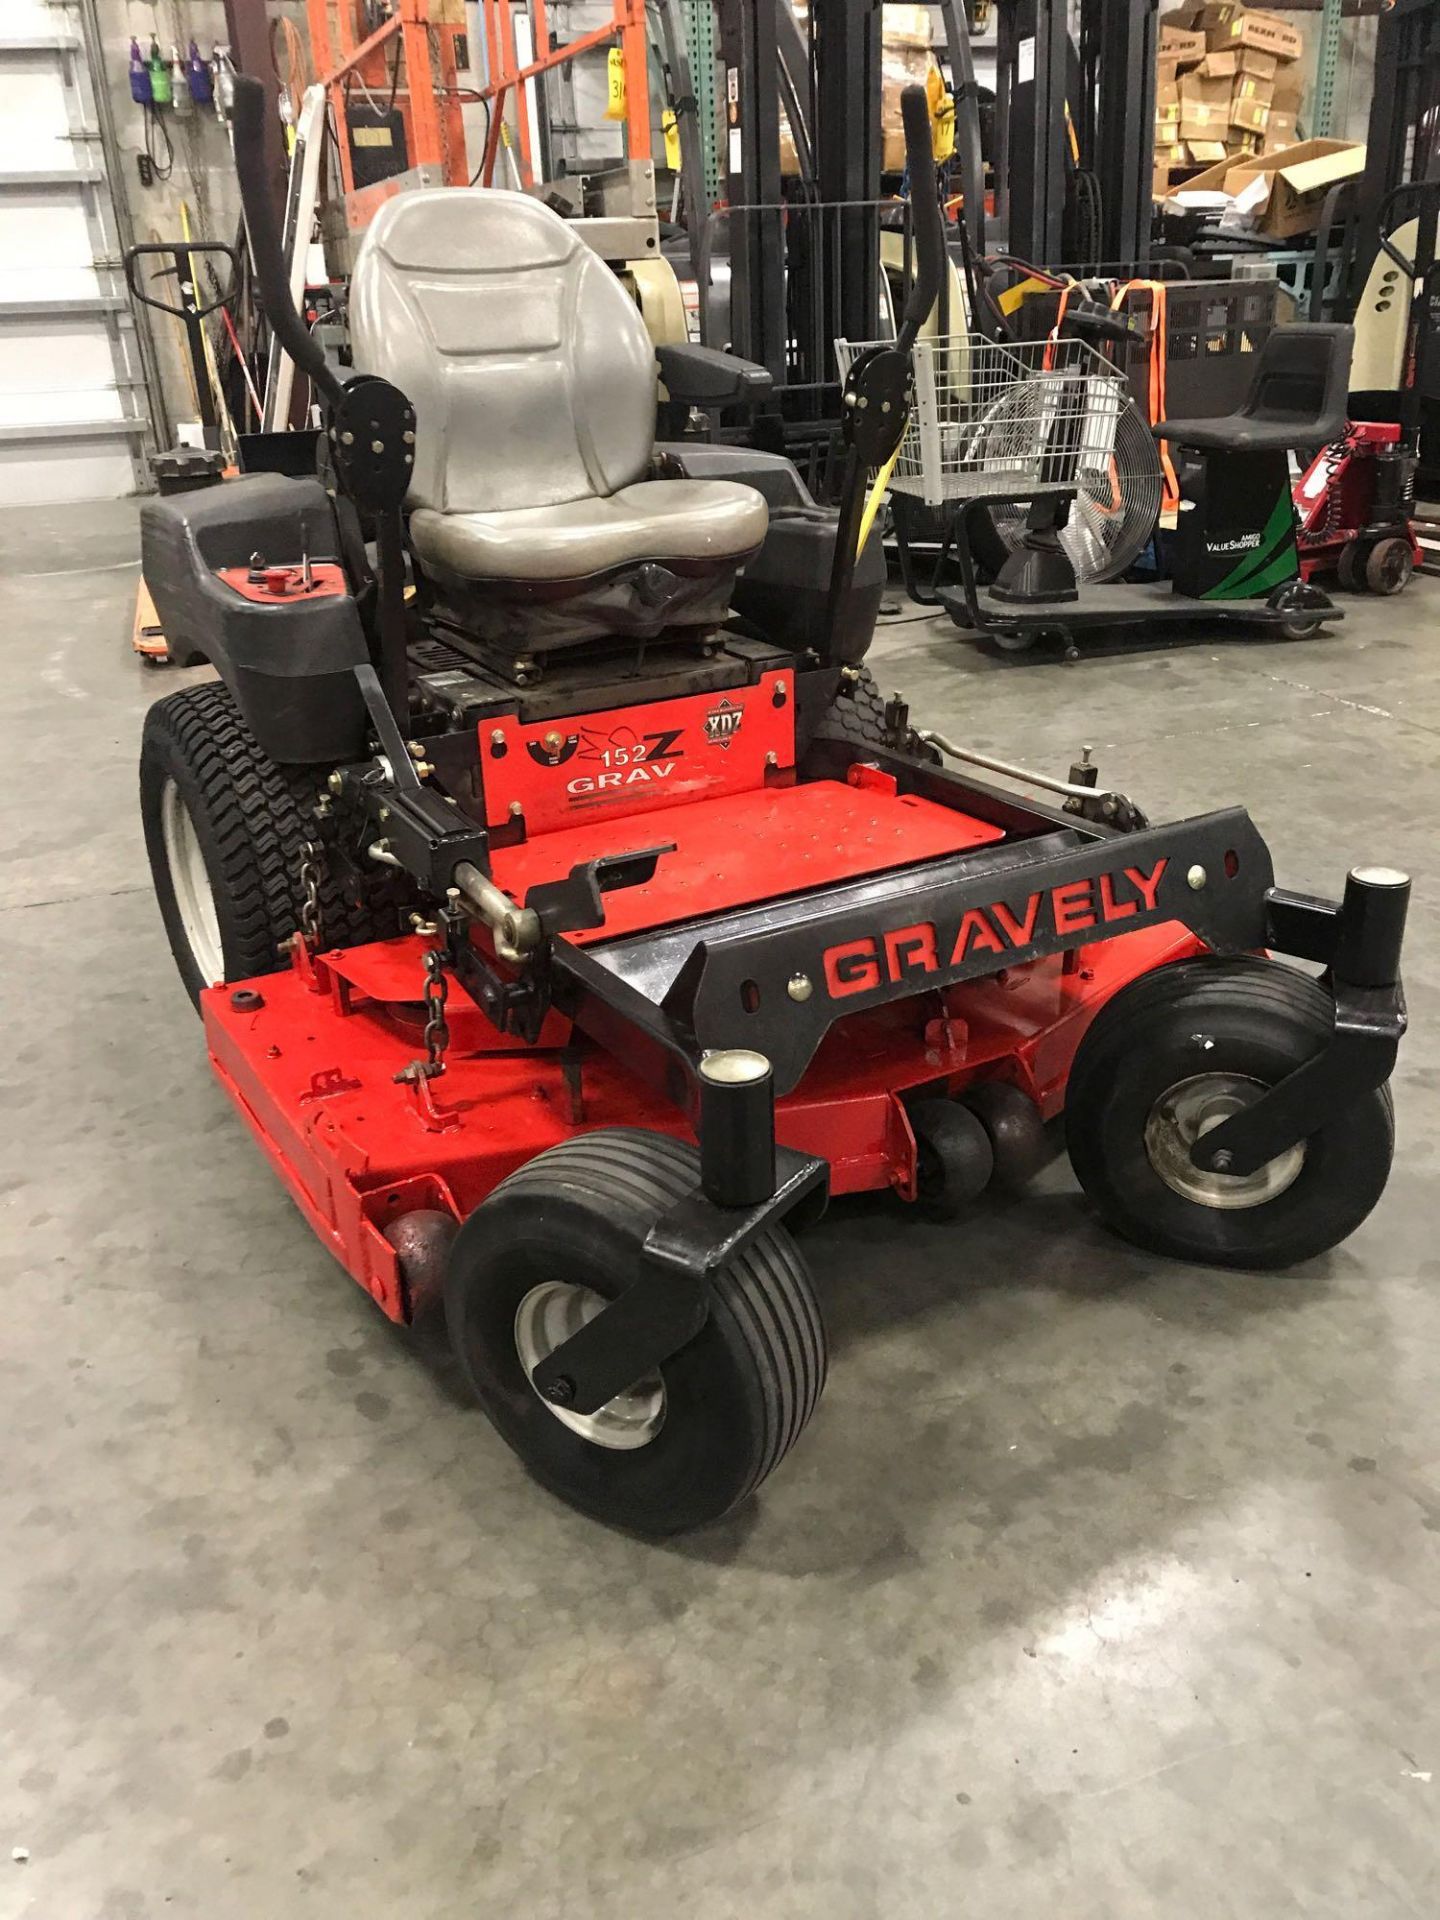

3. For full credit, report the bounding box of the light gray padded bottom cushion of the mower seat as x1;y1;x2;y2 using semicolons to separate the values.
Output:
411;480;770;580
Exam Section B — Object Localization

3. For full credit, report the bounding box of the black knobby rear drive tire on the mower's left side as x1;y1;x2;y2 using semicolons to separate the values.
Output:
140;684;399;1000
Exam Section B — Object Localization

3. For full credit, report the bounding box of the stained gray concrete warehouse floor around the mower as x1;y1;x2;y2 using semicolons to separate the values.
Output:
0;507;1440;1920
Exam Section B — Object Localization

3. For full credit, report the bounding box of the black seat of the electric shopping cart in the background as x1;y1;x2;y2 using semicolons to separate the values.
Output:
1152;323;1356;453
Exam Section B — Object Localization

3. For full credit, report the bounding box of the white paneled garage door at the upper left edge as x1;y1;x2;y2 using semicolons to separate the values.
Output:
0;0;146;505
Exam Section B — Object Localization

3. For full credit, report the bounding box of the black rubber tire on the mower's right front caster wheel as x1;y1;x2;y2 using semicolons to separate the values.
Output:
1066;958;1394;1267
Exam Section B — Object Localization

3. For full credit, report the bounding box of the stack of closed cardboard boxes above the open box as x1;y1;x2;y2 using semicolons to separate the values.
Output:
1156;0;1302;194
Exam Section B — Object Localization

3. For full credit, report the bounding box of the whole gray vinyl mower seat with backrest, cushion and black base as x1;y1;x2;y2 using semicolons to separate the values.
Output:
349;188;768;651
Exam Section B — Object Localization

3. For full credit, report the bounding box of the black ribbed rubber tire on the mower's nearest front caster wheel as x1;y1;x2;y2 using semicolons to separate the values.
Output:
445;1127;828;1536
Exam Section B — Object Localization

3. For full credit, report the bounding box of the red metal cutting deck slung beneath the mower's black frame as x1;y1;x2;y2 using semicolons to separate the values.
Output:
204;924;1204;1321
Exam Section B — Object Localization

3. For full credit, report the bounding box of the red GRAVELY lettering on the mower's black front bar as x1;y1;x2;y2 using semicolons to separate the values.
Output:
824;858;1169;1000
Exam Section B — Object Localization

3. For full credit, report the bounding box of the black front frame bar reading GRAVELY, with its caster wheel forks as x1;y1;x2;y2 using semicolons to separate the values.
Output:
534;808;1409;1413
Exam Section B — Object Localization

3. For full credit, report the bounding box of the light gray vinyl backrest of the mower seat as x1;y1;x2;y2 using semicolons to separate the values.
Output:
349;186;655;513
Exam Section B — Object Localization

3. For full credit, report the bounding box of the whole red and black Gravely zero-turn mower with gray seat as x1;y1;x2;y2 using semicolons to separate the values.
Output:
140;81;1409;1534
